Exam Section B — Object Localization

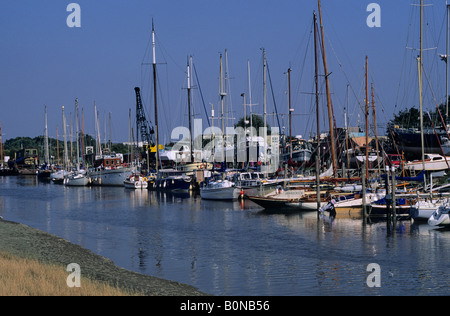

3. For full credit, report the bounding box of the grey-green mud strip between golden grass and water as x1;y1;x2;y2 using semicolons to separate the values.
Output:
0;219;209;296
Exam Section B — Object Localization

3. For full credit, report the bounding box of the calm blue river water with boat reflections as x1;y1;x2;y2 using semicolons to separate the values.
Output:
0;177;450;296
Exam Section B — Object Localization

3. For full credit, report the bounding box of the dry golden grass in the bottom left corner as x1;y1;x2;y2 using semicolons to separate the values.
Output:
0;252;141;296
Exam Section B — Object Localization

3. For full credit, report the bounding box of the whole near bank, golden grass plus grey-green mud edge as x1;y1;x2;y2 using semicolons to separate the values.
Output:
0;220;205;296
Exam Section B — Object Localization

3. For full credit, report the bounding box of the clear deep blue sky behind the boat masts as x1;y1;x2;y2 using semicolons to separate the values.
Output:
0;0;445;142
